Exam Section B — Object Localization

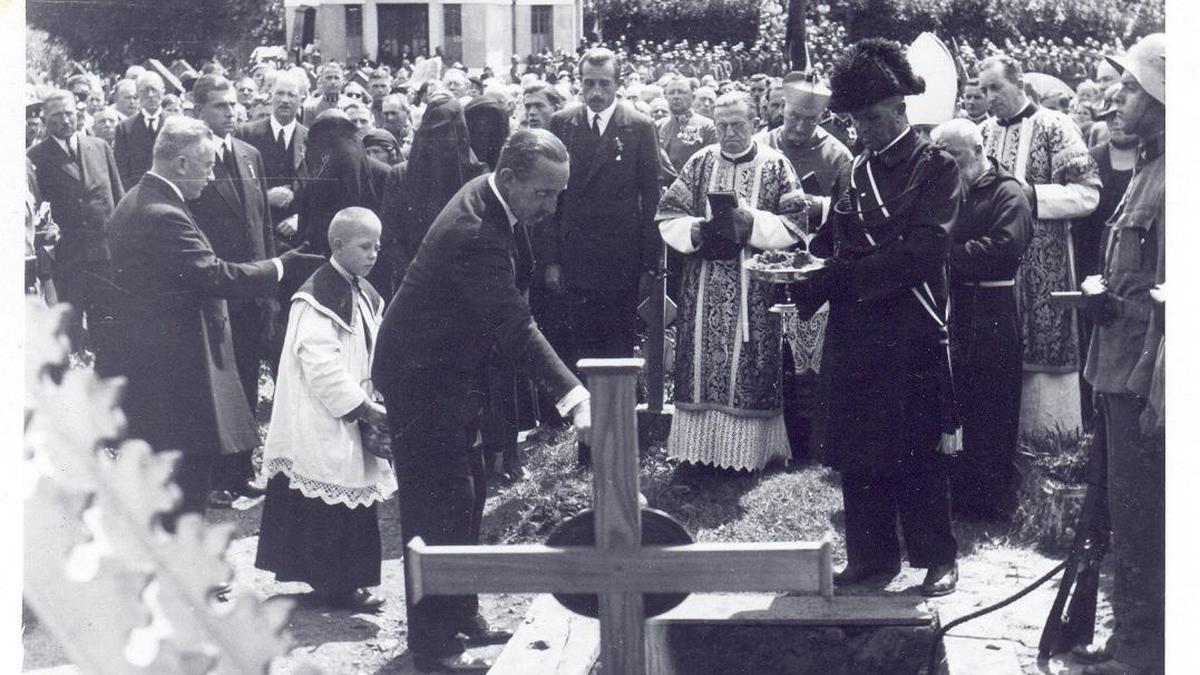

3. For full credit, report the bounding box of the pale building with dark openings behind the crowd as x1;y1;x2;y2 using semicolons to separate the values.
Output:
283;0;583;72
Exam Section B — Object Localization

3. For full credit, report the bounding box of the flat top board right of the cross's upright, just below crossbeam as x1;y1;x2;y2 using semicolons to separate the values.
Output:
648;593;936;626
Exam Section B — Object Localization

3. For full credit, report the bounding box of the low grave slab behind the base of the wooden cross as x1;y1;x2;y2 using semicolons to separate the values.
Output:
491;593;940;675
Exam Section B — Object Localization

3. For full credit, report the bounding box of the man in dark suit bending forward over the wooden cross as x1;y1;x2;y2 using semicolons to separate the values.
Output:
371;130;592;671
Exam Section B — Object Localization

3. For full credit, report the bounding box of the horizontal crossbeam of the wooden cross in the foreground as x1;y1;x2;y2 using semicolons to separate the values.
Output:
408;539;829;601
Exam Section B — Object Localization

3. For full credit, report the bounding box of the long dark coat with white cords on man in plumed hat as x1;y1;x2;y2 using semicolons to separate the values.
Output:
796;131;961;473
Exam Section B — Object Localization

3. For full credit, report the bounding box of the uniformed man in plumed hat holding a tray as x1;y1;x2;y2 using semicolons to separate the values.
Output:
796;38;961;596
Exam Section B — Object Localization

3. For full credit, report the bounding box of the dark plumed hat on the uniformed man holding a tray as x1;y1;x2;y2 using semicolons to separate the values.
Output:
829;37;925;113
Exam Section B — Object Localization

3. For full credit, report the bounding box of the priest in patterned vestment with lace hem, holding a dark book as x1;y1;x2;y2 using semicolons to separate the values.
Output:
655;92;808;471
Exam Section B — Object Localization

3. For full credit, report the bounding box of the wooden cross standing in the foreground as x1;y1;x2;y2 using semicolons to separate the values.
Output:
407;359;833;675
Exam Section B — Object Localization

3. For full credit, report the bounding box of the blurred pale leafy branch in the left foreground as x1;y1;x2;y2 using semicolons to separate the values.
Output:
24;303;292;674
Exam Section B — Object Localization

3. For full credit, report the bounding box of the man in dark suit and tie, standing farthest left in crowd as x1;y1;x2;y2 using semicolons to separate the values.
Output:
29;90;125;350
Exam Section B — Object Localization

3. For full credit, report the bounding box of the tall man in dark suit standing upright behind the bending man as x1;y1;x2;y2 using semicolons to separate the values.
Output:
545;48;662;363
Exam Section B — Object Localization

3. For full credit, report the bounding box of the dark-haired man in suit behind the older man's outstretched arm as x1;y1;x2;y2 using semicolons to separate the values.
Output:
187;74;278;506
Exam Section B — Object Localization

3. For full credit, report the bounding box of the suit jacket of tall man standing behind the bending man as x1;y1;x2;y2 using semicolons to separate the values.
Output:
541;101;662;291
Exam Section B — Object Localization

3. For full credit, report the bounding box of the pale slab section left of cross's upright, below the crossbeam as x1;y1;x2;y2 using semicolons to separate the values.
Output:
488;596;600;675
